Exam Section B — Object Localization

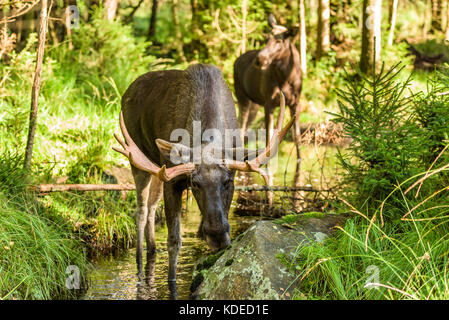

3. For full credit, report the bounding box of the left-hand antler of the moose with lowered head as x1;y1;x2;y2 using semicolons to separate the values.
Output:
112;111;195;182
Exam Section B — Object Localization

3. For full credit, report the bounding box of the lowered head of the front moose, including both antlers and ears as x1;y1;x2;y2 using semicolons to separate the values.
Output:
114;92;294;250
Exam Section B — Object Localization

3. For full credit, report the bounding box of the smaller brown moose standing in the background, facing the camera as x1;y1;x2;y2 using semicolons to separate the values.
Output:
234;14;302;186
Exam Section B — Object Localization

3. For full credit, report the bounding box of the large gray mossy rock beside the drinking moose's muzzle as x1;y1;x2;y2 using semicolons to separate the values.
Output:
192;214;345;300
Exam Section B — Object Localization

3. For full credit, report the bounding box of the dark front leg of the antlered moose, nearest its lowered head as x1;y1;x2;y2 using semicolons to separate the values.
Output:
164;183;183;283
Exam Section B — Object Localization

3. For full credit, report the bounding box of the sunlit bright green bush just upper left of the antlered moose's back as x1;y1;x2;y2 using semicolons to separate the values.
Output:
65;10;155;96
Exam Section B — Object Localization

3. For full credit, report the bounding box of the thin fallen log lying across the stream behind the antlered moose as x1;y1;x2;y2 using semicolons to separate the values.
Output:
35;183;331;193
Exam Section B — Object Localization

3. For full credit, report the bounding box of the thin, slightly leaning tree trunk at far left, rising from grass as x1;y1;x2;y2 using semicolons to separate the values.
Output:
24;0;48;169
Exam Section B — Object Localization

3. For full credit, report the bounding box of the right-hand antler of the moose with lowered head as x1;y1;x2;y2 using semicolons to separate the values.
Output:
226;91;295;184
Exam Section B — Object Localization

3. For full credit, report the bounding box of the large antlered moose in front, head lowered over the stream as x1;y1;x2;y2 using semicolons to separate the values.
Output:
114;64;293;292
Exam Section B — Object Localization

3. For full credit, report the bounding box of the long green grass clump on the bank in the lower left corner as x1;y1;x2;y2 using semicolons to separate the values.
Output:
0;154;87;299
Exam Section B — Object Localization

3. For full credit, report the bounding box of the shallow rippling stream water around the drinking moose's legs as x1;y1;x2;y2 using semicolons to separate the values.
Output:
83;200;258;300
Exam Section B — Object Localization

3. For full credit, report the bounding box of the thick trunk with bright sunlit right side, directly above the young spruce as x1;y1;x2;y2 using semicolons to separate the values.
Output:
360;0;382;74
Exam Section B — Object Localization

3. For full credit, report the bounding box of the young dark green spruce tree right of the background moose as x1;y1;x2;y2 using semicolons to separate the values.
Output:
334;65;426;215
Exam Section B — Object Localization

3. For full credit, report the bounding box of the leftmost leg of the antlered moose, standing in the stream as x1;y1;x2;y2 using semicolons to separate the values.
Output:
131;166;151;275
